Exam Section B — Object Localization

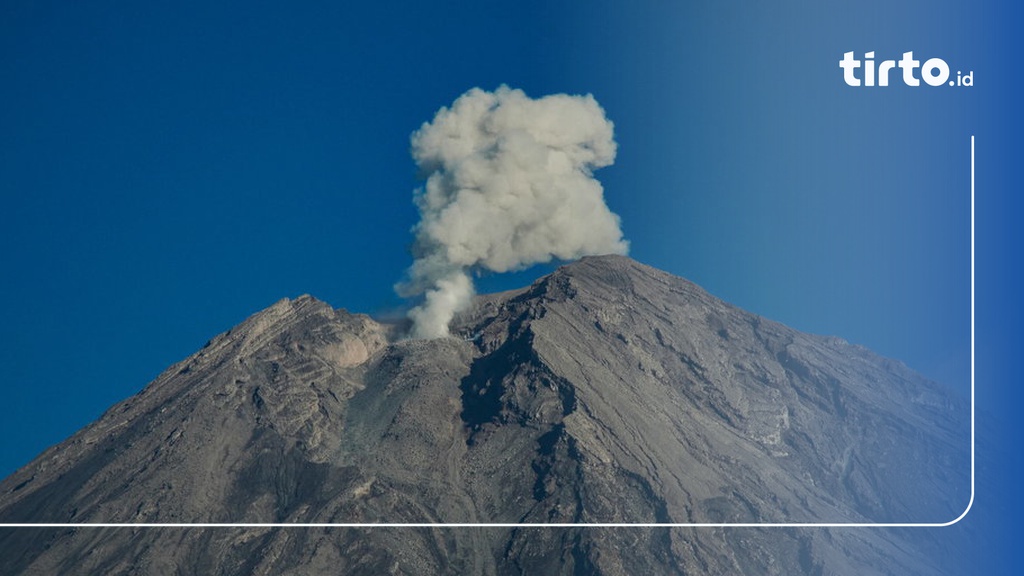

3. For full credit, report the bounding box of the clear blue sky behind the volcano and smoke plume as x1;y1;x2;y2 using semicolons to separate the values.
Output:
0;0;1024;565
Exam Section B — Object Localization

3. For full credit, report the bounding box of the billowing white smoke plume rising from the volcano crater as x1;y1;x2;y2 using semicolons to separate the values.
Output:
395;86;629;338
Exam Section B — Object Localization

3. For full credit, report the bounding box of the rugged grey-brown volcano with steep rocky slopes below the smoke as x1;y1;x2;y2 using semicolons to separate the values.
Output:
0;256;970;575
